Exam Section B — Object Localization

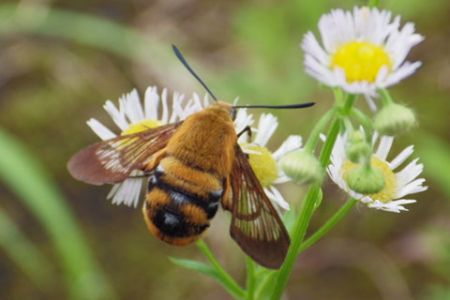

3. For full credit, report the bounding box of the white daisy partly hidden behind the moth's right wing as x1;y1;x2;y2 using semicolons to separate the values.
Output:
235;110;302;210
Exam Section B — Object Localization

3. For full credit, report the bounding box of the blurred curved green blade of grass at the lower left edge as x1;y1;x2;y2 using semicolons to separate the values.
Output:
0;129;115;299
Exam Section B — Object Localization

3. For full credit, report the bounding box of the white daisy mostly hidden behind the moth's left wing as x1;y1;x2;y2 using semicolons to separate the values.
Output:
87;86;208;207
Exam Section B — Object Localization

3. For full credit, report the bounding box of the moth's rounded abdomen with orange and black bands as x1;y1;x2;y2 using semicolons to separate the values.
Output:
144;156;223;245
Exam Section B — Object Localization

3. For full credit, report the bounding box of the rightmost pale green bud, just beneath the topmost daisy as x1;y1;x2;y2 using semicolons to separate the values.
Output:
374;103;417;135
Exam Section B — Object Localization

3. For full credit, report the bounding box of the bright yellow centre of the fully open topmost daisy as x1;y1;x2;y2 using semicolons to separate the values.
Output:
330;42;392;82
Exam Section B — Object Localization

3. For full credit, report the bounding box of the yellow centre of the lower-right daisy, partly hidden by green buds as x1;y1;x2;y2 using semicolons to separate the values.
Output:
341;155;397;203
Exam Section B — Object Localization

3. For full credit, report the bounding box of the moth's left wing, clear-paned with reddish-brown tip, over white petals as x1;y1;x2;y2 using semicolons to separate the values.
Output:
67;122;181;185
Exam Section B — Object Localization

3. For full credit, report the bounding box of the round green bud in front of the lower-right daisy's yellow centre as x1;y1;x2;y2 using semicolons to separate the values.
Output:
344;165;384;195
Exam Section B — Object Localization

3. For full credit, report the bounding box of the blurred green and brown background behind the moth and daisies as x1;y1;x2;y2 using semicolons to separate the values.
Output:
0;0;450;299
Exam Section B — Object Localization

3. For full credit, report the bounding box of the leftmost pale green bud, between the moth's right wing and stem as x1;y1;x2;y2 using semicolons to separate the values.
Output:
280;149;323;184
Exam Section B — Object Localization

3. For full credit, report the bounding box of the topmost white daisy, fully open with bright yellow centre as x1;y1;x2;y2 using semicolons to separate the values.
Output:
301;7;423;96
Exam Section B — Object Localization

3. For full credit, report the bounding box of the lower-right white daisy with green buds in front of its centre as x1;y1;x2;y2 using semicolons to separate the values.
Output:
327;134;427;213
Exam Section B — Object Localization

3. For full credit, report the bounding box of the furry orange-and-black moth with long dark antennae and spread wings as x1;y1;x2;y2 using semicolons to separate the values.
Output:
68;46;313;269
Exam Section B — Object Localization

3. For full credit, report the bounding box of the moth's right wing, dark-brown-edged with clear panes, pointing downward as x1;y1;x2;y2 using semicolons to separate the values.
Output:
230;145;290;269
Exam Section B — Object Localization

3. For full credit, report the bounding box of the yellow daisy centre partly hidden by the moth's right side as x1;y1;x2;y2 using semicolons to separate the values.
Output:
243;144;278;187
